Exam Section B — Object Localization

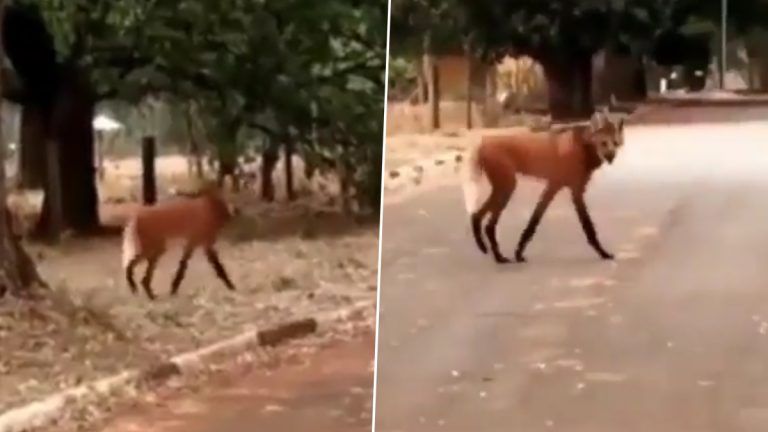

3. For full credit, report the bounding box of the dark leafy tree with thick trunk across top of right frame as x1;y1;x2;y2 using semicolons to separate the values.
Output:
392;0;768;118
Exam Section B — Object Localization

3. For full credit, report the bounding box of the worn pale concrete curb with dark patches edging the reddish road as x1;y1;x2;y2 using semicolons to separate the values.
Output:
0;301;375;432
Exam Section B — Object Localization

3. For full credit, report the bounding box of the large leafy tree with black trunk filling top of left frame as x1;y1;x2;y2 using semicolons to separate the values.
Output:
4;0;386;238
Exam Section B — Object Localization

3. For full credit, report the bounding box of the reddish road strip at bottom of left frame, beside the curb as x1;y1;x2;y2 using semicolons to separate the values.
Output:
97;335;374;432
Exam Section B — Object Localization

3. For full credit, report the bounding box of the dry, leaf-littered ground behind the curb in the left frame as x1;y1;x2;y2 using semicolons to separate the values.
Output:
0;159;378;412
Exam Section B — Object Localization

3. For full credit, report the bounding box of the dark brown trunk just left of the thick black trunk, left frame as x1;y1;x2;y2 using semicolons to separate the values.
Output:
19;105;46;189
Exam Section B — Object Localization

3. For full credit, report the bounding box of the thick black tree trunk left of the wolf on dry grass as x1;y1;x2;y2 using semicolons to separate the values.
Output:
37;67;99;234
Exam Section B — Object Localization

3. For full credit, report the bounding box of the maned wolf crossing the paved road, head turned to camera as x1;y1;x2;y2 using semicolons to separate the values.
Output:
464;111;623;263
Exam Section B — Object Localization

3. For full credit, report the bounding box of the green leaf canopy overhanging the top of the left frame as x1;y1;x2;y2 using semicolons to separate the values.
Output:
22;0;387;208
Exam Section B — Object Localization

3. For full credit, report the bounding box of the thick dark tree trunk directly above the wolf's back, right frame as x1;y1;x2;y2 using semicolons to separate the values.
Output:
540;54;595;121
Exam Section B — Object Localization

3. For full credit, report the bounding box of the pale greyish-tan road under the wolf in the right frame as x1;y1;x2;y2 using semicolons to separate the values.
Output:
376;111;768;432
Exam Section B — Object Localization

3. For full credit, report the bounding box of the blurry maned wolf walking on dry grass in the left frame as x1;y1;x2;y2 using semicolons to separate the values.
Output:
123;188;234;299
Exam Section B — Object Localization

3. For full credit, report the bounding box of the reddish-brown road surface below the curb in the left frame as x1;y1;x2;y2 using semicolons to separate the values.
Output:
64;331;374;432
